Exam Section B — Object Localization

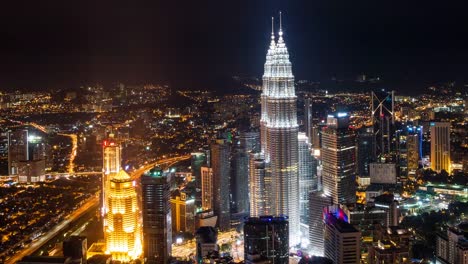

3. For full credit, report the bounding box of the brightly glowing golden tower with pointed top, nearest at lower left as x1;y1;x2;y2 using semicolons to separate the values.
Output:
104;170;142;262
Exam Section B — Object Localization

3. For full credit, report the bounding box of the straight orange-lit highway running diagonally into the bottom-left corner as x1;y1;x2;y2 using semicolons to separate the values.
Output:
5;195;99;264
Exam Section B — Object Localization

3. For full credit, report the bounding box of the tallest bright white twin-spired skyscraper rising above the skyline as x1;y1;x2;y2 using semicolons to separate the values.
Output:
260;13;300;241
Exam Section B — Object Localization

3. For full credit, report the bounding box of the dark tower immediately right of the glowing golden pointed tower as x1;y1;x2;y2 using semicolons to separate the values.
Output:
141;169;172;264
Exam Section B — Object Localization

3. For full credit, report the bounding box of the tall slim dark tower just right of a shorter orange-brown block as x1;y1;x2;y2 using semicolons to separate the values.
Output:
211;140;231;231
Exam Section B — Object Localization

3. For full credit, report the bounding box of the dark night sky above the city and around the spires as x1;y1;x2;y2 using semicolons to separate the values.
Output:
0;0;468;90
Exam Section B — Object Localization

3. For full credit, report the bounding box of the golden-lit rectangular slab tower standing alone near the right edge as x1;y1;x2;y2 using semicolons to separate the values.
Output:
431;122;450;173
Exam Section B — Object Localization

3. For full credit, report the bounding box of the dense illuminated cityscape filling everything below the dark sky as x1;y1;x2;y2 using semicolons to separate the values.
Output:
0;2;468;264
